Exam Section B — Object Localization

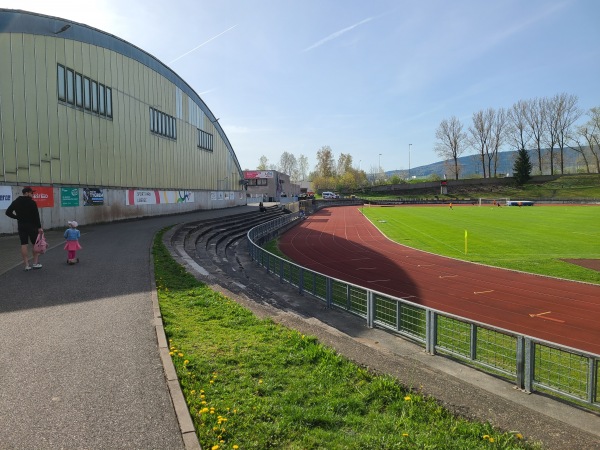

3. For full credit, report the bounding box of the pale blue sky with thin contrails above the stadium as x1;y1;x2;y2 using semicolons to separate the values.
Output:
0;0;600;172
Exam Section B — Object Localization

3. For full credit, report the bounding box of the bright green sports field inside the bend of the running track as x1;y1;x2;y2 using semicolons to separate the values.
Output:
361;205;600;284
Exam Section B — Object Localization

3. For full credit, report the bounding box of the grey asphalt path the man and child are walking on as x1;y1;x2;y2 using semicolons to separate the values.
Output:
0;207;256;449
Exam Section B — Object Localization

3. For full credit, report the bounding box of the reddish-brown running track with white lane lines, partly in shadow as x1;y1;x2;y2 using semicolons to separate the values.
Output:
279;206;600;355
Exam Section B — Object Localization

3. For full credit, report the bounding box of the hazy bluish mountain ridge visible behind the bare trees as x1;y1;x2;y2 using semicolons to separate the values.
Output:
385;148;580;178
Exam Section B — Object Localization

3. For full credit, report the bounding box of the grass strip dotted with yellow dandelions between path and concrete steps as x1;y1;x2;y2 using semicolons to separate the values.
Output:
153;233;539;450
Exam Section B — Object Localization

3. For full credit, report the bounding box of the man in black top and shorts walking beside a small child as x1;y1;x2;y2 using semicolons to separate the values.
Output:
6;187;44;270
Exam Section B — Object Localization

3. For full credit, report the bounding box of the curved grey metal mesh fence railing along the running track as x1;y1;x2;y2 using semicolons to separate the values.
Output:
248;209;600;408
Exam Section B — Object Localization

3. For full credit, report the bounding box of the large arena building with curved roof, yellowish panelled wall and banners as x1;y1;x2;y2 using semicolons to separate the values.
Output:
0;9;246;233
